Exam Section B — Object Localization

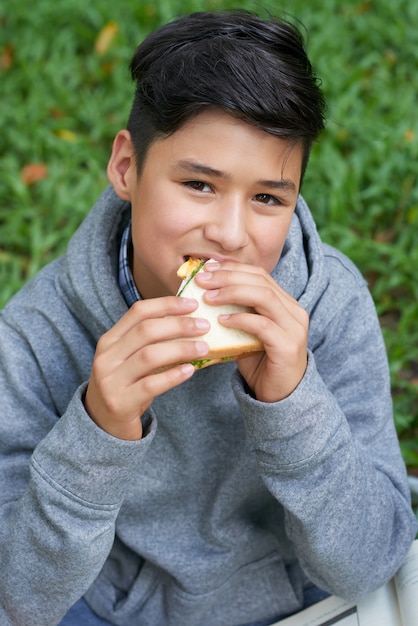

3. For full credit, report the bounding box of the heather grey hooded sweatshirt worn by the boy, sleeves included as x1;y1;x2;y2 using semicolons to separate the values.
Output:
0;188;416;626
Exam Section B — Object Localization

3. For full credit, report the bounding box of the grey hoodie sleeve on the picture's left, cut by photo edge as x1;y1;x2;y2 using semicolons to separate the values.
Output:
0;320;155;626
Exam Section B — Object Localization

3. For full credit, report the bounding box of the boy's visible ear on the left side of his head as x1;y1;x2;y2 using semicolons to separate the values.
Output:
107;130;136;200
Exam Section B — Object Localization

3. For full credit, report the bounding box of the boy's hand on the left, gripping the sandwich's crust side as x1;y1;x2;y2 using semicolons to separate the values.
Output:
84;296;209;440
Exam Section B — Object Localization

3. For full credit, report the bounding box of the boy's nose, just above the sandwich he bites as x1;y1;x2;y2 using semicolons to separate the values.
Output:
204;199;250;252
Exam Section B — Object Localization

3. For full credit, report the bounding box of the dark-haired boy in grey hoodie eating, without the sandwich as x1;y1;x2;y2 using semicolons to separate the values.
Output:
0;12;416;626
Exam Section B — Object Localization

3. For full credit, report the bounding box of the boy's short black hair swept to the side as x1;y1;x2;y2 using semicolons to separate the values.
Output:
128;10;325;175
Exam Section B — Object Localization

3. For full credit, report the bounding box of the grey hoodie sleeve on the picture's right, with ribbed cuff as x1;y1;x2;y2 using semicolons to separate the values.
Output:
234;270;416;599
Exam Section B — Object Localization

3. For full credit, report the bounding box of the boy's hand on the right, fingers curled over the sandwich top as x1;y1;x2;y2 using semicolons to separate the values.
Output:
196;263;309;402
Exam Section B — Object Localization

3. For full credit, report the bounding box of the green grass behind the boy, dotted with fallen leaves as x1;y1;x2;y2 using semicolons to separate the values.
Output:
0;0;418;474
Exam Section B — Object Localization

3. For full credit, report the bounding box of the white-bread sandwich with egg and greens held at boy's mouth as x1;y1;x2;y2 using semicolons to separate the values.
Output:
177;258;263;368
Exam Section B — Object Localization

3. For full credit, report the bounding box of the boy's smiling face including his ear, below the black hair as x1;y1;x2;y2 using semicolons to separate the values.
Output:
108;110;302;298
